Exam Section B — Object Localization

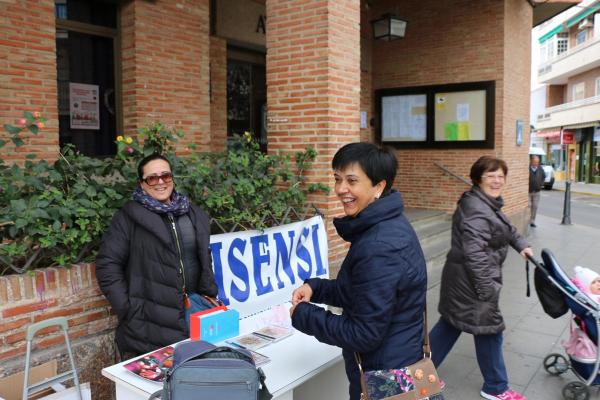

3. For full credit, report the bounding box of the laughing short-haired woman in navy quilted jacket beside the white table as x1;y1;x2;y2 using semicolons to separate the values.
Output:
290;143;427;400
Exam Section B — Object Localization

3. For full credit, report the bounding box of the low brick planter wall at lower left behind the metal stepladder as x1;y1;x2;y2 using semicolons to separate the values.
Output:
0;264;117;399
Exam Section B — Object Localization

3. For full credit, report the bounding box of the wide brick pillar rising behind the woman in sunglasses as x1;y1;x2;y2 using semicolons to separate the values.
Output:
121;0;210;152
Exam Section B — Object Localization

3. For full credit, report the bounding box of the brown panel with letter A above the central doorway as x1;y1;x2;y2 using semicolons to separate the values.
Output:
215;0;266;47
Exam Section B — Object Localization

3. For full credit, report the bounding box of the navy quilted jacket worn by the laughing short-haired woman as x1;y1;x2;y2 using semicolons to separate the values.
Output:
292;192;427;400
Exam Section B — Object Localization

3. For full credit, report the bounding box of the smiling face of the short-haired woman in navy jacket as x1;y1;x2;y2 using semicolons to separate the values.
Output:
333;163;385;217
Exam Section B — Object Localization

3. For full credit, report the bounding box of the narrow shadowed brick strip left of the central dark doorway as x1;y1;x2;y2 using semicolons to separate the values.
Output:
210;36;227;151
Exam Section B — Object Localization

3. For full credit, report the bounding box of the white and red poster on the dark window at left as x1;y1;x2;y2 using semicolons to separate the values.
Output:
69;82;100;129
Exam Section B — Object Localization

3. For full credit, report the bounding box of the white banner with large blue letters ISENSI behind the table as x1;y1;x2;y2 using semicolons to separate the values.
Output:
210;216;329;316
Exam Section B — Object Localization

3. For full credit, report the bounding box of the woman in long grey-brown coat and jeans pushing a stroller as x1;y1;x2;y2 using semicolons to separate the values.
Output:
429;156;533;400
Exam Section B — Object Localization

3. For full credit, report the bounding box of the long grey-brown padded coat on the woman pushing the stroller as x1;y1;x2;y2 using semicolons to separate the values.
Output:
438;186;529;335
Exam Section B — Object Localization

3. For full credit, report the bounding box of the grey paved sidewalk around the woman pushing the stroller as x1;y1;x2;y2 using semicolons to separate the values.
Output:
427;214;600;400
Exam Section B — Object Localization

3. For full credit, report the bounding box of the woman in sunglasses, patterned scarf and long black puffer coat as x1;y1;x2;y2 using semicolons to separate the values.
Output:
96;154;217;357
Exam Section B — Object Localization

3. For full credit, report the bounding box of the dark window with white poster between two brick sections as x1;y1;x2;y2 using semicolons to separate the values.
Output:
55;0;118;156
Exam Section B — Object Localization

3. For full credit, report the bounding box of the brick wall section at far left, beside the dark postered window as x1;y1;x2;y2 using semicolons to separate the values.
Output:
0;0;58;162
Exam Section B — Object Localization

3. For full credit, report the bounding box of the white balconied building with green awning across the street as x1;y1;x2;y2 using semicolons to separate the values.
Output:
535;0;600;183
